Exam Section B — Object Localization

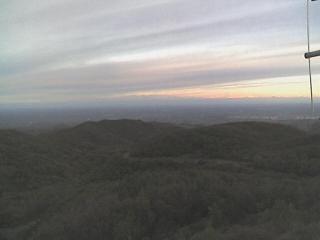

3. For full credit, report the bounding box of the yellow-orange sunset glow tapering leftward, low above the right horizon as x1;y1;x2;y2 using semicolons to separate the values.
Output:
128;76;318;99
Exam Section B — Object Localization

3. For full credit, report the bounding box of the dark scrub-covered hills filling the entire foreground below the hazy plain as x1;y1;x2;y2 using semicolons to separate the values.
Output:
0;120;320;240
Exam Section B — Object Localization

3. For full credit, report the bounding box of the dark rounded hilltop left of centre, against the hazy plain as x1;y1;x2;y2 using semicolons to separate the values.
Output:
42;120;177;151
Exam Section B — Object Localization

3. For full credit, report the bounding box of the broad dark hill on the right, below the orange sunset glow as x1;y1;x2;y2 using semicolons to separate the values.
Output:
135;122;306;158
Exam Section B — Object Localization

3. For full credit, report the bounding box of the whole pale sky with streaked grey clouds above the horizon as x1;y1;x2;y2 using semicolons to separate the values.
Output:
0;0;320;106
